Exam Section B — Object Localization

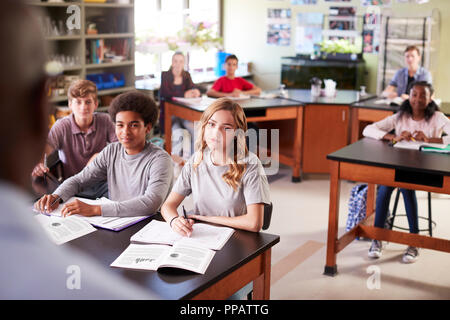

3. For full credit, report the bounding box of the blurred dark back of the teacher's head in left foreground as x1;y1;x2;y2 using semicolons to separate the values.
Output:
0;0;49;187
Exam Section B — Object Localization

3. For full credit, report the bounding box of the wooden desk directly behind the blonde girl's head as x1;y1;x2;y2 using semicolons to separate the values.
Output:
164;98;303;182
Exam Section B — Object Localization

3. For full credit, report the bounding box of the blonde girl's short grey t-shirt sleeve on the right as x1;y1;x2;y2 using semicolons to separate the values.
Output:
242;159;270;206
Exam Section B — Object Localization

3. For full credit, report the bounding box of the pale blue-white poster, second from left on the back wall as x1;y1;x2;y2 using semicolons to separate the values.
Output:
295;12;323;54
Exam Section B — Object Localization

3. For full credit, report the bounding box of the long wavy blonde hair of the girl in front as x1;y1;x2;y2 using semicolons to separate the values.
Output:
193;98;248;191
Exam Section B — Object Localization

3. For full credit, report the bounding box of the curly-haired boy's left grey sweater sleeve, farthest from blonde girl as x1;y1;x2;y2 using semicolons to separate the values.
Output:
54;147;110;201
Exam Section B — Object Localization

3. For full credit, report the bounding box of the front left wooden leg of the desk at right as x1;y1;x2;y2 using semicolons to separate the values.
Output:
324;161;340;276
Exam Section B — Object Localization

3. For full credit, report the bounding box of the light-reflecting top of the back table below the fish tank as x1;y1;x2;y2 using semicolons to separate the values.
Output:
286;89;374;105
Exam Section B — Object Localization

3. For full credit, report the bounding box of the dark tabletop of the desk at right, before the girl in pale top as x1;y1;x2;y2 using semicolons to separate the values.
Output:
327;138;450;176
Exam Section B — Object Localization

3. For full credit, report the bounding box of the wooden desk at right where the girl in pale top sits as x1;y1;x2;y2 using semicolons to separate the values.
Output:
324;138;450;275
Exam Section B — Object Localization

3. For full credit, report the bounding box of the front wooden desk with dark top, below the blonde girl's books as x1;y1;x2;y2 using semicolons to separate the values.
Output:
64;217;280;299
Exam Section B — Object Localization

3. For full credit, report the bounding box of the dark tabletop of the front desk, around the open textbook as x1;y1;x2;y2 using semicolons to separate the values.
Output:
65;216;280;299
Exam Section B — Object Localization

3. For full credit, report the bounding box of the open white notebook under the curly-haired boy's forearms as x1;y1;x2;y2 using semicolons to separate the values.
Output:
33;197;149;231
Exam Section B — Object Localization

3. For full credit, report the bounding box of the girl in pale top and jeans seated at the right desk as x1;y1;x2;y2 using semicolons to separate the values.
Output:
363;81;450;263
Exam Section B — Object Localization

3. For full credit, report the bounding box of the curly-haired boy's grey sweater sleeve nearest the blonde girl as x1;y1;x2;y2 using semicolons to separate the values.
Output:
102;153;173;217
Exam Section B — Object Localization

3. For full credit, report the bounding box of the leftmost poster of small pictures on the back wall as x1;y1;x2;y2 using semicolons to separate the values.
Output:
267;9;291;46
